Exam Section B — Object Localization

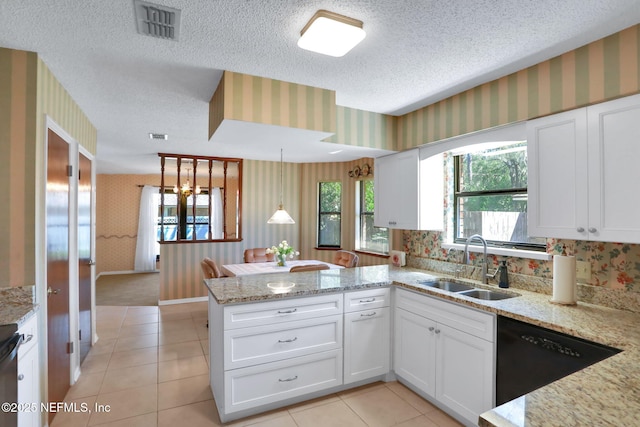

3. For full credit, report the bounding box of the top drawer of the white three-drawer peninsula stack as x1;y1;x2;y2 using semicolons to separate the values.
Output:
224;294;342;330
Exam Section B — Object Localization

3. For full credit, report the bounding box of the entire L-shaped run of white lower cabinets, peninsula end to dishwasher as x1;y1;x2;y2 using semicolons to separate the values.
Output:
209;288;495;425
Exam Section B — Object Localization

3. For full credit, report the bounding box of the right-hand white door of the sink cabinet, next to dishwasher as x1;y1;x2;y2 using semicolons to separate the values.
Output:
435;323;495;423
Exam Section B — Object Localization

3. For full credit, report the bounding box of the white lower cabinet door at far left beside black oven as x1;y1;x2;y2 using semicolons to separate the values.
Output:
18;345;40;427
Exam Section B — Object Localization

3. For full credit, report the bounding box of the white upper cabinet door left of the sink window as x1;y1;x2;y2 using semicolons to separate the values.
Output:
374;149;420;230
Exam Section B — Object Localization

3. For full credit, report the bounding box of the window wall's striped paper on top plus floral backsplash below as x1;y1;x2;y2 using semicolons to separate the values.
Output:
398;25;640;292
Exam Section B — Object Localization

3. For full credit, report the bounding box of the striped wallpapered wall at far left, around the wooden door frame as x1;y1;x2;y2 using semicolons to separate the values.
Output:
0;48;97;286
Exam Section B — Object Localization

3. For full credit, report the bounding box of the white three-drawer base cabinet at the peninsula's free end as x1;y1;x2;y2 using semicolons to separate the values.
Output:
209;293;343;422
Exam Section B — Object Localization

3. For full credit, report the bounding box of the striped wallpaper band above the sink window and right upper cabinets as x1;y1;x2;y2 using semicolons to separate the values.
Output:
396;25;640;151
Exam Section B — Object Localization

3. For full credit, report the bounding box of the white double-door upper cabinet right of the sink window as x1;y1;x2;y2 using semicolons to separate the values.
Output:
527;95;640;243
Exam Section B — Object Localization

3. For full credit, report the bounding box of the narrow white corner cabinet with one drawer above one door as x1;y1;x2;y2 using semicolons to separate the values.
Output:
344;288;391;384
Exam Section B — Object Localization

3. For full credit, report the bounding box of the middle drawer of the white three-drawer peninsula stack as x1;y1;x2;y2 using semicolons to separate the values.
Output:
224;314;342;370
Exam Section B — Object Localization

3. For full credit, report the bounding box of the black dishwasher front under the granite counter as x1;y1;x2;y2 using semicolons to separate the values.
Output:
496;316;620;405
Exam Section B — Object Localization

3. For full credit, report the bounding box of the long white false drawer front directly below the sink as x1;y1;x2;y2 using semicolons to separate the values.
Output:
396;289;496;342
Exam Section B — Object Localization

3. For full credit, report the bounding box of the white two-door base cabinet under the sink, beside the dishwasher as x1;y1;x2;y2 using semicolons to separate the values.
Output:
394;289;495;425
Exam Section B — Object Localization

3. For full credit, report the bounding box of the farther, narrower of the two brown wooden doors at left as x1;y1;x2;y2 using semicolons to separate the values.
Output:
78;153;93;363
